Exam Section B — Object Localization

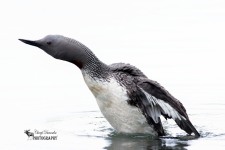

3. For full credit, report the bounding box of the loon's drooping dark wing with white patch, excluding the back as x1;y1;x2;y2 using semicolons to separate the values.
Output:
138;79;200;137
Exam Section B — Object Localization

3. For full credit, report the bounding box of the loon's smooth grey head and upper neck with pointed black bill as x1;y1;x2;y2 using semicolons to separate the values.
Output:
19;35;95;69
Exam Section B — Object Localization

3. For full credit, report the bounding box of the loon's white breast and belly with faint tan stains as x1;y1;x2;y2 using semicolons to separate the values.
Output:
83;73;157;135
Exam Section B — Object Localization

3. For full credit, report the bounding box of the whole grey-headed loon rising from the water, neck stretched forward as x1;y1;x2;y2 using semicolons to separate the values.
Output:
19;35;200;137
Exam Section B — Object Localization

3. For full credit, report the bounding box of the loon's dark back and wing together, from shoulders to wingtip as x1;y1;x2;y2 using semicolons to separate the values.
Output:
110;63;200;137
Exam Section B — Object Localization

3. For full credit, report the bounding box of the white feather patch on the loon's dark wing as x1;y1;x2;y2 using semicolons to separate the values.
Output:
140;88;185;123
